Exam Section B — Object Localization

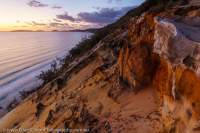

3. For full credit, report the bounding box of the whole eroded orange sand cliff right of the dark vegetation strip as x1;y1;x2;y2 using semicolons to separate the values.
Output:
0;1;200;133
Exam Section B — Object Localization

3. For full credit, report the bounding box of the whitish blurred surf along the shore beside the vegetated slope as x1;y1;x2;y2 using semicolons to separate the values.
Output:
0;32;89;117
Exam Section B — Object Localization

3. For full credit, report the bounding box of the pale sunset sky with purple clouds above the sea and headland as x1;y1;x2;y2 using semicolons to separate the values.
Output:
0;0;144;31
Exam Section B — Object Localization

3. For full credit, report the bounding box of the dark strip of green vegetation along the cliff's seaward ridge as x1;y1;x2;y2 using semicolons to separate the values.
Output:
38;0;181;85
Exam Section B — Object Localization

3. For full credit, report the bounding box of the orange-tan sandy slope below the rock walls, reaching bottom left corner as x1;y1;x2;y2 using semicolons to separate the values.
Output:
0;47;160;133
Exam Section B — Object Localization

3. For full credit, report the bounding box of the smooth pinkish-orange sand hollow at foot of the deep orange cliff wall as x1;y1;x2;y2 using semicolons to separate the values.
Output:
110;88;161;133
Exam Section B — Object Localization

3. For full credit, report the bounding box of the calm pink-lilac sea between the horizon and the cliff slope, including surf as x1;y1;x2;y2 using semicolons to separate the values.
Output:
0;32;90;106
